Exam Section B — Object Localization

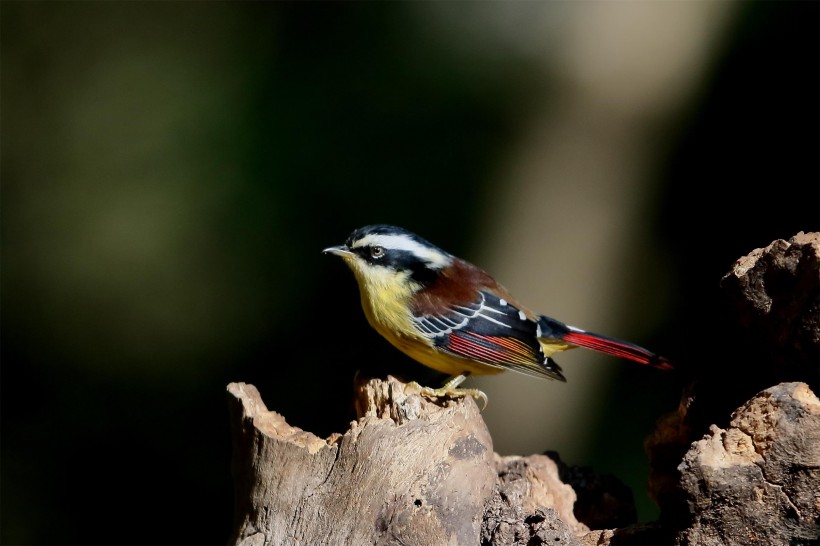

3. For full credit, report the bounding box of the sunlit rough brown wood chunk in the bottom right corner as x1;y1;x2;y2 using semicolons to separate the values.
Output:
679;383;820;546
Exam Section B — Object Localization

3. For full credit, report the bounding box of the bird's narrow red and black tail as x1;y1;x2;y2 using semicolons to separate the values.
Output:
538;316;673;370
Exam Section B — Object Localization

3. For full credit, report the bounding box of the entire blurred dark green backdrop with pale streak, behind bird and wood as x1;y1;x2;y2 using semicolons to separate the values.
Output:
0;0;820;544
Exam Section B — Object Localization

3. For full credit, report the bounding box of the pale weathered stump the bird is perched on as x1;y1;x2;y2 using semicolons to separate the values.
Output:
228;378;495;546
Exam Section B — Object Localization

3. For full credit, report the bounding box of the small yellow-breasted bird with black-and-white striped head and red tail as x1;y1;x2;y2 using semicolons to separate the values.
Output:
323;224;672;407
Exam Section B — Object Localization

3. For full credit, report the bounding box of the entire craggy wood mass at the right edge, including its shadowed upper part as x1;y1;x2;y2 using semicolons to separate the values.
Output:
646;232;820;545
